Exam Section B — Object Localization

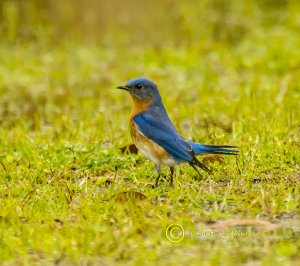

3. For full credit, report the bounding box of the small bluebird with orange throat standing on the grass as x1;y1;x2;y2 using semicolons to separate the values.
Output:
117;78;239;186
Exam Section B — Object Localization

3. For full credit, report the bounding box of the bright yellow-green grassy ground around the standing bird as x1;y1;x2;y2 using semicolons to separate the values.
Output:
0;1;300;265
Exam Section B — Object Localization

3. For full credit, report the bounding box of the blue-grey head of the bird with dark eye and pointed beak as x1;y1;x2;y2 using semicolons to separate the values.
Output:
117;78;161;101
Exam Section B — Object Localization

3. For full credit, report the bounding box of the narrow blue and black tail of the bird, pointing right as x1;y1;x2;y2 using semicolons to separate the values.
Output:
189;141;239;155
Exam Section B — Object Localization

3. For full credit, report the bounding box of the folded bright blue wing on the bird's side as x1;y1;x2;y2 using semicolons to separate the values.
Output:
133;112;194;162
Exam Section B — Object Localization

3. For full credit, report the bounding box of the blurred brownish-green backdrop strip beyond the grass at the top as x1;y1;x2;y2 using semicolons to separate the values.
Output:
0;0;300;48
